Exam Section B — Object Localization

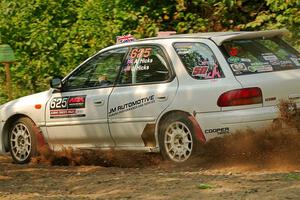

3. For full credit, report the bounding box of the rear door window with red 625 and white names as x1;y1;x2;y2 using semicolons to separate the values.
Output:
119;46;171;85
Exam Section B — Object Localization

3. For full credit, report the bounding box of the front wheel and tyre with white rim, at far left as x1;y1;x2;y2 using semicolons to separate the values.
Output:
9;117;39;164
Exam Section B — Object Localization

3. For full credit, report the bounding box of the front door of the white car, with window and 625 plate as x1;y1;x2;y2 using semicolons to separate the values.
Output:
46;48;127;147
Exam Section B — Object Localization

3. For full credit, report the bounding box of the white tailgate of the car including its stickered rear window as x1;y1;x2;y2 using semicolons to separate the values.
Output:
221;37;300;107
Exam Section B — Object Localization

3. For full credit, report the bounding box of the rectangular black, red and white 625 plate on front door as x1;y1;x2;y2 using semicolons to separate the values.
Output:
50;95;86;118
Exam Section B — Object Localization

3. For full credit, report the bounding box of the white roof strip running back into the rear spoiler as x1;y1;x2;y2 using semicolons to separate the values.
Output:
138;29;288;46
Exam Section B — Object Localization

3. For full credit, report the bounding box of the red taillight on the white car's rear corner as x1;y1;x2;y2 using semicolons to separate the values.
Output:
218;87;262;107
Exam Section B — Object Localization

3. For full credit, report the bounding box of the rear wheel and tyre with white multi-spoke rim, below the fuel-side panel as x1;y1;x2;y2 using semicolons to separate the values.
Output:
158;114;198;162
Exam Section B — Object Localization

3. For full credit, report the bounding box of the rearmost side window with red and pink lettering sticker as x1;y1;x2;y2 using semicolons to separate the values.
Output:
174;42;225;80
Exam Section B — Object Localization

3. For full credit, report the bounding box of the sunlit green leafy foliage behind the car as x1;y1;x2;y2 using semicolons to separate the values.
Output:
0;0;300;104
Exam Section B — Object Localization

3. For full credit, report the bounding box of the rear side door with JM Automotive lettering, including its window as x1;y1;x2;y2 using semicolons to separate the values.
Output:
108;45;178;147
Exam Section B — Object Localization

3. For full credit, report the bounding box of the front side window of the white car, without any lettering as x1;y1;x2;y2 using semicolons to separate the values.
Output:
63;47;128;90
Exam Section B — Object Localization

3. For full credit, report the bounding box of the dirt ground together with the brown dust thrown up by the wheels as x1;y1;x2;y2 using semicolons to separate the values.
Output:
0;111;300;200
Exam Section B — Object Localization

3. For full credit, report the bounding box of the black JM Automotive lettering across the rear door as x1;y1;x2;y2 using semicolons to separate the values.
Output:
108;95;155;117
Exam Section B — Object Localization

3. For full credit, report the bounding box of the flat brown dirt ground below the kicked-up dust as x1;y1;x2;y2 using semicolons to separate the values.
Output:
0;149;300;200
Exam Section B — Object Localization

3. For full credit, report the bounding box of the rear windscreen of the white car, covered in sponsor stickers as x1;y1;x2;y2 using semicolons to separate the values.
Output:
222;38;300;75
